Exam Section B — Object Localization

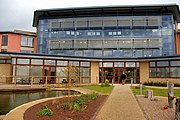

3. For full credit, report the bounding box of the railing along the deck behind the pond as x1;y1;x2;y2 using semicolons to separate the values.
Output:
0;75;93;89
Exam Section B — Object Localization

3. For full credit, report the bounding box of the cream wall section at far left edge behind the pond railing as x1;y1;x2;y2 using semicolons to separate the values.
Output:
0;64;11;83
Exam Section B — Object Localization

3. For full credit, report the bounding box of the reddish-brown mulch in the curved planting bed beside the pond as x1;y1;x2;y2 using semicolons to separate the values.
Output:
24;95;107;120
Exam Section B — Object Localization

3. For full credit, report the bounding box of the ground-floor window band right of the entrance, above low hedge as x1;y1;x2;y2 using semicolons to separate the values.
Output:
149;60;180;78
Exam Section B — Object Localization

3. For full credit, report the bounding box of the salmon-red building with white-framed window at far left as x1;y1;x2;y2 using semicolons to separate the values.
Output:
0;30;37;53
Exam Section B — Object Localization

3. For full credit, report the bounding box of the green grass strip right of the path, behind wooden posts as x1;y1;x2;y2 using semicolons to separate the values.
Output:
132;87;180;97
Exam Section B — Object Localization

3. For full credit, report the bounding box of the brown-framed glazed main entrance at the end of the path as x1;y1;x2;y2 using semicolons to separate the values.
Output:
99;62;140;83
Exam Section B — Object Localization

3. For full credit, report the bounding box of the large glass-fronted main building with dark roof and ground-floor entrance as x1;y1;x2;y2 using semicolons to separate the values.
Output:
0;5;180;84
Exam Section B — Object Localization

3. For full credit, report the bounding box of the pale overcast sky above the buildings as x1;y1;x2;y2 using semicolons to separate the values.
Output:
0;0;180;32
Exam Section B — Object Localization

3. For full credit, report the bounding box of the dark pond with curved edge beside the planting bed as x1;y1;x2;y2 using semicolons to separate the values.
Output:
0;91;80;115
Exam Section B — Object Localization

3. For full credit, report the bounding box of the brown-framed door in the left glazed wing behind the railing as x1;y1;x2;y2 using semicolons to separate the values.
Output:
44;66;56;83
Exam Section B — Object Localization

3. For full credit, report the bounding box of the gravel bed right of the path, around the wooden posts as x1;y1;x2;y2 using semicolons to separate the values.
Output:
136;95;175;120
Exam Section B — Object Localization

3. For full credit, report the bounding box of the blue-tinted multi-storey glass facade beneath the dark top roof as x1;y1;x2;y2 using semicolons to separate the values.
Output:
37;14;175;58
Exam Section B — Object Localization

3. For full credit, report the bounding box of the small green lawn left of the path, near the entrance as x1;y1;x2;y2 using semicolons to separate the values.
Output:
76;85;114;94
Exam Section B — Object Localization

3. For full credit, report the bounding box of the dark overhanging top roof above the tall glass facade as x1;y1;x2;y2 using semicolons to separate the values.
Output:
33;4;180;27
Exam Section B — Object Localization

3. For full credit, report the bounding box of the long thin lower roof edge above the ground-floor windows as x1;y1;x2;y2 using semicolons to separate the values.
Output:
0;52;180;62
